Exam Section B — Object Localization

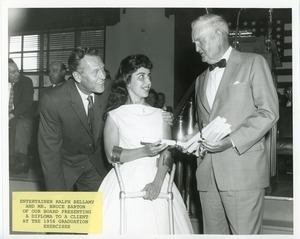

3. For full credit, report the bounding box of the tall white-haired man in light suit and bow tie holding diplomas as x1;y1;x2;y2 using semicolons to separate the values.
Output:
192;14;279;234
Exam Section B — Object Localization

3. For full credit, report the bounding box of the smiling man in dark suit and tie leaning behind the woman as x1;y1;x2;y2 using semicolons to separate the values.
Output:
38;47;110;191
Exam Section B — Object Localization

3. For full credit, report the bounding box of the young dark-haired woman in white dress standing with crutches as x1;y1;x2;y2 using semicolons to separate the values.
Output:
99;55;193;235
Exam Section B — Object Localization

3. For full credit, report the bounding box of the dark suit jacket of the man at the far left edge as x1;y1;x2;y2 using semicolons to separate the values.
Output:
11;75;34;118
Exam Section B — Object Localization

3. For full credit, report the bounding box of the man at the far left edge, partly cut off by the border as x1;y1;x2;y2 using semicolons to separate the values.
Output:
8;58;34;174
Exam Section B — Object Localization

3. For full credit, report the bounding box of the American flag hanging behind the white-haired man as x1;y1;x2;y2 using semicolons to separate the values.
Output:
228;15;292;91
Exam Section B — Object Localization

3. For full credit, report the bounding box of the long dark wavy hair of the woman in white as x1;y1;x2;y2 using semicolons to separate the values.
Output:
104;54;153;119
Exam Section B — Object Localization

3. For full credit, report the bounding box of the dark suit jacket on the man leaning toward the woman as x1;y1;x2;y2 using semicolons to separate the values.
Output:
38;79;110;191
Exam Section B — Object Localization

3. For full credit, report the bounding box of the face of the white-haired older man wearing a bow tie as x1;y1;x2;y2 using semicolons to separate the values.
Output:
192;23;222;64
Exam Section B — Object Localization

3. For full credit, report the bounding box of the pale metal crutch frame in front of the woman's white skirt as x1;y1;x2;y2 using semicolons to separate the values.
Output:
113;158;176;234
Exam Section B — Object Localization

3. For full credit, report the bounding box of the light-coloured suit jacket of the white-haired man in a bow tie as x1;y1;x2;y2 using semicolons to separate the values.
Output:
196;49;279;191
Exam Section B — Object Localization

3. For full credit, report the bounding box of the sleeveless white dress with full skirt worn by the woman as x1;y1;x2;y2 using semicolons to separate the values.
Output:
99;104;193;235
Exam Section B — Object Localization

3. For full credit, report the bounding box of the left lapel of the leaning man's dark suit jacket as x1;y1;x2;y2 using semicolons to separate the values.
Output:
68;81;93;137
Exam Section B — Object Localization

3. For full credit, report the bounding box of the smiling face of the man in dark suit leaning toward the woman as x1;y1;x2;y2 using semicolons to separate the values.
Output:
73;55;106;95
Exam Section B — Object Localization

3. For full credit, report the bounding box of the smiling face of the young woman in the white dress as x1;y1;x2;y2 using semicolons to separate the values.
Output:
127;67;151;103
